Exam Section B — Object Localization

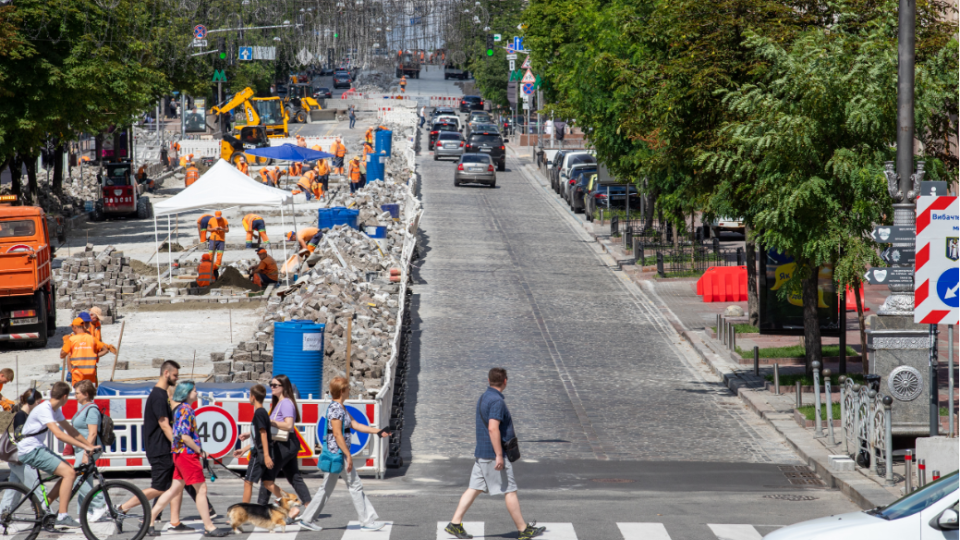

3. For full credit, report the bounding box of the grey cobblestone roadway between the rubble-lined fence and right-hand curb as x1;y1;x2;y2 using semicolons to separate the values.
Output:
404;141;796;463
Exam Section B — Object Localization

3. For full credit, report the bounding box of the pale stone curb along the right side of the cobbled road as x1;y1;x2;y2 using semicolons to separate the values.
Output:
513;155;900;509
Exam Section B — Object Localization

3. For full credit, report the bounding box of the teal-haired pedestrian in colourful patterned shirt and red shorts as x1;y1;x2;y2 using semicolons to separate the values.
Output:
147;380;230;538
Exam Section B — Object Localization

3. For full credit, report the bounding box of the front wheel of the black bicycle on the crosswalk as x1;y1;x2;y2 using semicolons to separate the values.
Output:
80;480;150;540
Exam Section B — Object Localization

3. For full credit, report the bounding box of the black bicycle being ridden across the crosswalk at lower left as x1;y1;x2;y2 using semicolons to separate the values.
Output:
0;452;150;540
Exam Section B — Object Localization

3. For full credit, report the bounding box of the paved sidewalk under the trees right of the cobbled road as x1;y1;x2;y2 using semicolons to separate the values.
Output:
514;150;947;508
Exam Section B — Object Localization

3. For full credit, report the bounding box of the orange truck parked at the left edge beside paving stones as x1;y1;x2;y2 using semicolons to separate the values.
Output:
0;195;57;348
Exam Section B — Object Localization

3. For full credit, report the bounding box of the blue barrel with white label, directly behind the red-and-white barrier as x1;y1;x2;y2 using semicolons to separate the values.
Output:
273;320;325;399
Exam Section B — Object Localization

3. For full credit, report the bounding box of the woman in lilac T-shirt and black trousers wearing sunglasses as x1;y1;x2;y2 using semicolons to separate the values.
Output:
257;375;313;519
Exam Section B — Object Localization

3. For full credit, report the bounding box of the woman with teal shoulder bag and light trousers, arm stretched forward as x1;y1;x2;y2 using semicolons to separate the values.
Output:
300;377;390;531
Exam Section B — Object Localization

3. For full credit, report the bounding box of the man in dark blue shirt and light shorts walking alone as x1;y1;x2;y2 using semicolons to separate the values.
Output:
444;368;546;540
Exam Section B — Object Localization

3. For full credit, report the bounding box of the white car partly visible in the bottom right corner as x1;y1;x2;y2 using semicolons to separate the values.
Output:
764;471;960;540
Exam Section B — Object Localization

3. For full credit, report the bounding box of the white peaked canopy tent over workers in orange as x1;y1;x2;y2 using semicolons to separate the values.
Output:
153;159;297;284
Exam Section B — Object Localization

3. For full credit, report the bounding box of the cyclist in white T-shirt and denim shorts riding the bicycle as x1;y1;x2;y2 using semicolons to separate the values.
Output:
17;381;100;529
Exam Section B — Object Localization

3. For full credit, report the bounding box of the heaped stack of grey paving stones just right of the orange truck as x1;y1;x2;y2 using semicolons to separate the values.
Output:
53;244;142;314
